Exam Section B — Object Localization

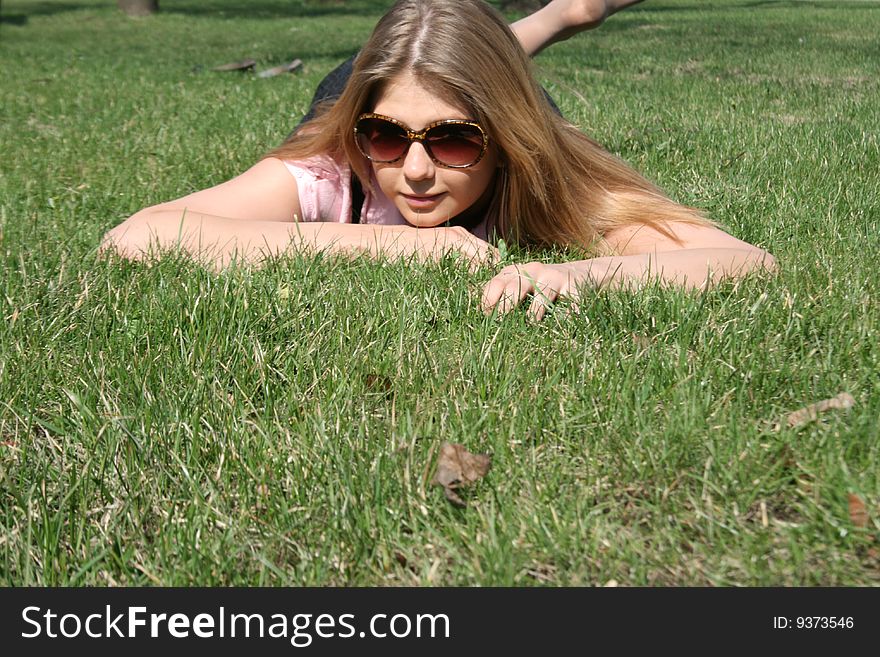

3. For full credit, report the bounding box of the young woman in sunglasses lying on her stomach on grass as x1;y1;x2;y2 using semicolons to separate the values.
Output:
104;0;774;319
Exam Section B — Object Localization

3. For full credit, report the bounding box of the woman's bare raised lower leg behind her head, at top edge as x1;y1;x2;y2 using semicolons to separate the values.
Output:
510;0;642;57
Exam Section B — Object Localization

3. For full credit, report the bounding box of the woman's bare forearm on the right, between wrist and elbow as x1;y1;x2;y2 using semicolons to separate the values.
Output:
569;248;776;288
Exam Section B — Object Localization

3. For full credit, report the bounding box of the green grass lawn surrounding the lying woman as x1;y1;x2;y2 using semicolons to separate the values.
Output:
0;0;880;586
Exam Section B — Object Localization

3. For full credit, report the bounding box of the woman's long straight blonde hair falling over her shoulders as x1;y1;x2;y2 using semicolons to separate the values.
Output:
266;0;709;250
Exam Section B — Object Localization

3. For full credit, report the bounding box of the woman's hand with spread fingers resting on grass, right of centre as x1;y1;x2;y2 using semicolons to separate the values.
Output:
481;262;595;321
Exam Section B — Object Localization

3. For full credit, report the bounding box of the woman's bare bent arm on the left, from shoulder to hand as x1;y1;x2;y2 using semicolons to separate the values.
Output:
102;158;494;266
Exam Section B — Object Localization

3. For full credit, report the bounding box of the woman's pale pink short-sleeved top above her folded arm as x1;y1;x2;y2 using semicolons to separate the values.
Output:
284;156;488;240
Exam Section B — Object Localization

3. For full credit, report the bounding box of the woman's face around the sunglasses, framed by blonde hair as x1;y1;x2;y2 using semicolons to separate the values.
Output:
372;73;498;228
